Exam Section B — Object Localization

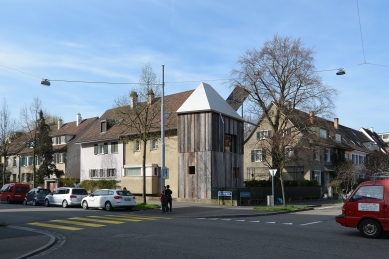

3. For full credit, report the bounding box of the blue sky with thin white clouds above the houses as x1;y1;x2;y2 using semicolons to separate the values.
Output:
0;0;389;133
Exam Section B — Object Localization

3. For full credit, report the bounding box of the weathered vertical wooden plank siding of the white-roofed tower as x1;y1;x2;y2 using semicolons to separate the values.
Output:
177;112;244;199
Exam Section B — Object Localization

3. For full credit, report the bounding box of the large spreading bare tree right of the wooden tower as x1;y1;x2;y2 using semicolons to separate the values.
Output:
231;35;336;206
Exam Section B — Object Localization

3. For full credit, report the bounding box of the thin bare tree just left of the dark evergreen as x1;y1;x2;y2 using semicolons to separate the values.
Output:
20;97;42;187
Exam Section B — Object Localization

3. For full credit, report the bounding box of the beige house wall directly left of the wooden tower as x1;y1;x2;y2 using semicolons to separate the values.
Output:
121;136;178;198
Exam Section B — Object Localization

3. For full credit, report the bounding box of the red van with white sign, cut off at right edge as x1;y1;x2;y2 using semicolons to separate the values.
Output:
335;177;389;238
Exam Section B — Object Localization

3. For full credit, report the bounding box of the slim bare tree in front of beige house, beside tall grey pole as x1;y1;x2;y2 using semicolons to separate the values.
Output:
115;63;161;203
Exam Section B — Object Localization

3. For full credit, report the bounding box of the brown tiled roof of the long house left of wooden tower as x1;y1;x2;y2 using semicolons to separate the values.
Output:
77;90;193;143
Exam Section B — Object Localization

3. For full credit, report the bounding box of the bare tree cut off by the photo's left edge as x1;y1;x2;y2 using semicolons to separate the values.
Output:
0;98;16;184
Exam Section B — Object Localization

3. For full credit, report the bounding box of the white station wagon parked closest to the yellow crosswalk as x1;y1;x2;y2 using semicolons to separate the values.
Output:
81;189;136;211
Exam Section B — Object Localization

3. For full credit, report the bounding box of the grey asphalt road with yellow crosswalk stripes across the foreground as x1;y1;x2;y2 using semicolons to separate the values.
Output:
0;204;389;259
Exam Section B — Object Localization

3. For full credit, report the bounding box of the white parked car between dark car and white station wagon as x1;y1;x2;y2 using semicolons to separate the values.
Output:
45;187;88;208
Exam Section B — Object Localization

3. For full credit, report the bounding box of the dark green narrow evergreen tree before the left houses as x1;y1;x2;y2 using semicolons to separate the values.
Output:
35;110;54;184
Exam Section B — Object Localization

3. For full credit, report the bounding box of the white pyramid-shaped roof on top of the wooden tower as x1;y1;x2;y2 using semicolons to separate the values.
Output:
177;83;242;120
